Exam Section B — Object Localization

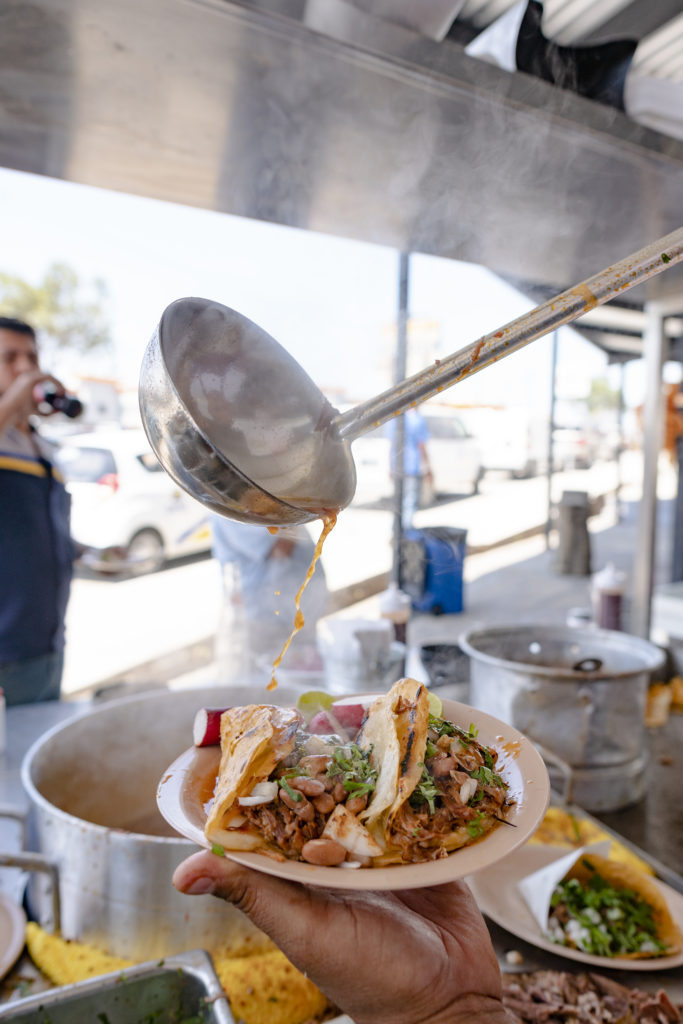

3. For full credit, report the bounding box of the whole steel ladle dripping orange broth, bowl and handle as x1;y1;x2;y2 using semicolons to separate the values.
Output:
139;228;683;526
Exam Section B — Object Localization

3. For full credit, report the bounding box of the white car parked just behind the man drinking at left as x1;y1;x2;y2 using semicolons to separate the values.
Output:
57;429;211;573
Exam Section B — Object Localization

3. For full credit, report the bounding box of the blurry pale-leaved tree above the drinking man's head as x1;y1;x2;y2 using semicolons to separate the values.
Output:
0;263;112;353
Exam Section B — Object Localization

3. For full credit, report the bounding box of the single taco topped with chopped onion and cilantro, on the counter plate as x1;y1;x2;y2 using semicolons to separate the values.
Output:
547;854;683;959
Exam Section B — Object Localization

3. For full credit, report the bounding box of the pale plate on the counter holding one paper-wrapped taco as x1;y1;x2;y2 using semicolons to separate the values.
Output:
468;843;683;971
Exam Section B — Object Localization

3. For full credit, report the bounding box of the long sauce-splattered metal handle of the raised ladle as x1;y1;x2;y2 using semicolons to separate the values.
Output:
335;227;683;441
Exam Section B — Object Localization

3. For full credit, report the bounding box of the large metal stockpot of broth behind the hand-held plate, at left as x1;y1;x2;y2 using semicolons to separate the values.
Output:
22;686;297;961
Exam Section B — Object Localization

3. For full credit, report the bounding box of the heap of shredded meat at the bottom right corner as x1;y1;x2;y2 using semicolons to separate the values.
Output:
503;971;683;1024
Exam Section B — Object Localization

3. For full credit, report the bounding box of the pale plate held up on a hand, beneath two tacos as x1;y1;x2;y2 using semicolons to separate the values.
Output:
157;695;550;890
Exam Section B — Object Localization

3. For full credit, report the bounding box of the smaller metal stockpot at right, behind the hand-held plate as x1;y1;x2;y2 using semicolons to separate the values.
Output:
460;626;665;811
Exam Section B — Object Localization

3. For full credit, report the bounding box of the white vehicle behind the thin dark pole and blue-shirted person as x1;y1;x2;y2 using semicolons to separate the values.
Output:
352;409;483;507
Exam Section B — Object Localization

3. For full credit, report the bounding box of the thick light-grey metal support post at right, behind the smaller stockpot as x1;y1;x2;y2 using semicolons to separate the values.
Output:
631;302;668;639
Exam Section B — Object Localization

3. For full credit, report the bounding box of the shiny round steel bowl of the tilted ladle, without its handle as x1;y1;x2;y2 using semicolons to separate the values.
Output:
139;298;355;525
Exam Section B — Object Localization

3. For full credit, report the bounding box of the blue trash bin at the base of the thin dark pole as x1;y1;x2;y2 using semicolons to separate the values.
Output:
399;526;467;615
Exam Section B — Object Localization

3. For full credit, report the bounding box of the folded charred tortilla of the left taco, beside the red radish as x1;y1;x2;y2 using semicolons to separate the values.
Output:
204;705;301;850
